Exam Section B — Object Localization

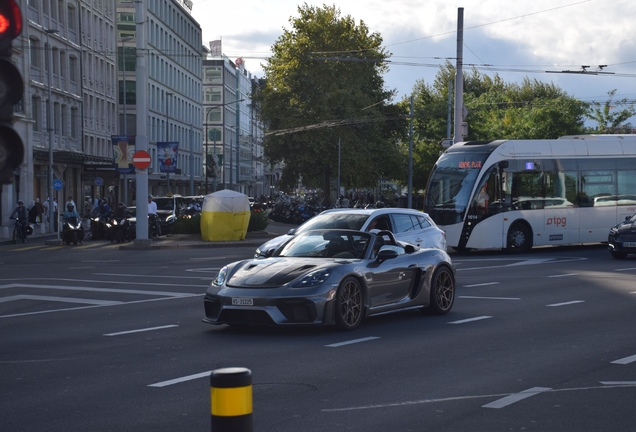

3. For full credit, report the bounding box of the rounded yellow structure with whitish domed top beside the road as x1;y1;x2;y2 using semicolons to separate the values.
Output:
201;189;250;241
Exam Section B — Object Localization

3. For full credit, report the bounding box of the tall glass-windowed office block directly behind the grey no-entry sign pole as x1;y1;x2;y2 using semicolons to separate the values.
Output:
117;0;204;202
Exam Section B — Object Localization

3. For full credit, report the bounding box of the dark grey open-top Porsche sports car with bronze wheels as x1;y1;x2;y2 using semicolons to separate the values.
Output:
203;229;455;330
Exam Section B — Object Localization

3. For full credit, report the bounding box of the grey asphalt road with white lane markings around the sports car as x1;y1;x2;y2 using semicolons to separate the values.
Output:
0;243;636;432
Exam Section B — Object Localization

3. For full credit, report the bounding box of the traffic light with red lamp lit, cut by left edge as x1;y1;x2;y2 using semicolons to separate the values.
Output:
0;0;24;184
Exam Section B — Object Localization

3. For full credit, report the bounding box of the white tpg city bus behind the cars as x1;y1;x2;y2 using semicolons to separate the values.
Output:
424;135;636;253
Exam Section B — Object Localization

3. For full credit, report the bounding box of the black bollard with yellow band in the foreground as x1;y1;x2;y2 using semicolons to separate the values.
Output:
210;368;253;432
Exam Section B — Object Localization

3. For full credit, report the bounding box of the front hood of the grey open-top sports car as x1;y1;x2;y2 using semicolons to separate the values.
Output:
226;258;333;288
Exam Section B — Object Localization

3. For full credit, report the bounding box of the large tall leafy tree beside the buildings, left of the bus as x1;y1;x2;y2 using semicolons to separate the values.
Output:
255;3;407;199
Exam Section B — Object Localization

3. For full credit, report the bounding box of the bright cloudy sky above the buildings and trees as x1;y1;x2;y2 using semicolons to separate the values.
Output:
192;0;636;113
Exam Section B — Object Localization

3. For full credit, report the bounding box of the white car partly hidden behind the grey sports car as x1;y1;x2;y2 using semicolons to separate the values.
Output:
254;208;446;258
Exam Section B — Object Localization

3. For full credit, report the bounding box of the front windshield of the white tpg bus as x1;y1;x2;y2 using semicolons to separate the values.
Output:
425;152;489;225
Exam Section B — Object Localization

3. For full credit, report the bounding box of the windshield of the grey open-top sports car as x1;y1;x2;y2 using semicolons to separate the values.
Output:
277;230;371;258
